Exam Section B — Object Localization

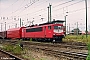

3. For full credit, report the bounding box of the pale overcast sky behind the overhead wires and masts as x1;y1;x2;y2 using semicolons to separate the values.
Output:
0;0;90;31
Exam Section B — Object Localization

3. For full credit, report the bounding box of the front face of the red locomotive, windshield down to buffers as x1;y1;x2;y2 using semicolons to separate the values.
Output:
53;24;64;42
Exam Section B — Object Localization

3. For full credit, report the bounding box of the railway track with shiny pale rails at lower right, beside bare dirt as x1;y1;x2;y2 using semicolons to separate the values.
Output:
29;46;88;60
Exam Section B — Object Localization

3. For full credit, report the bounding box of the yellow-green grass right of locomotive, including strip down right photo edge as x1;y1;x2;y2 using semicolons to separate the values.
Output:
63;35;90;60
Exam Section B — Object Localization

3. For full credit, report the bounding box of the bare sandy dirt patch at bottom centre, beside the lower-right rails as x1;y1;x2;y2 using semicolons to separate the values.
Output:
22;50;68;60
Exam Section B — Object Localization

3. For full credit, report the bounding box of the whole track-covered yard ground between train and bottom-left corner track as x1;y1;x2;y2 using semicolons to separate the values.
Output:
0;37;88;60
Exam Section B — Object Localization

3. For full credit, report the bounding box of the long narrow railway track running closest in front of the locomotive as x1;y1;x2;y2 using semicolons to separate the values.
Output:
22;41;88;50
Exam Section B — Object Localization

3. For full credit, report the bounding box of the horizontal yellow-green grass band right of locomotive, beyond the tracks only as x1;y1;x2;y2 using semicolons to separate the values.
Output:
63;35;90;43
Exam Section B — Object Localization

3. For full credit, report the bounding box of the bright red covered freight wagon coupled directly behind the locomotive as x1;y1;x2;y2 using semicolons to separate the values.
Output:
7;27;24;39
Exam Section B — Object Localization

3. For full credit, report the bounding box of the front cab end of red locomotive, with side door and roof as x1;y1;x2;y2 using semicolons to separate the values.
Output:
42;20;65;42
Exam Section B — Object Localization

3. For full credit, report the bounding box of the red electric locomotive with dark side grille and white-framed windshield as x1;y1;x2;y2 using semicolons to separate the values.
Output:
22;20;64;42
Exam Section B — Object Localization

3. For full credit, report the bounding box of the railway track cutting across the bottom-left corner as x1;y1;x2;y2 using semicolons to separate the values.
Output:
0;49;24;60
